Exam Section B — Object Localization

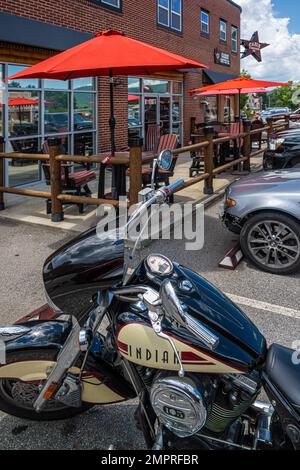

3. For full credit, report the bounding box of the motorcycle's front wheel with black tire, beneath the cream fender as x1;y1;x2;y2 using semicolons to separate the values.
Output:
0;350;91;421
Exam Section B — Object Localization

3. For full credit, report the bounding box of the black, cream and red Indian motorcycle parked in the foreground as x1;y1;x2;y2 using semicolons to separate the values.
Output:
0;152;300;450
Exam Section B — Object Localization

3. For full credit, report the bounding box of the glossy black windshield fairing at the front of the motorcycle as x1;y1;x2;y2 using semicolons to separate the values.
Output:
43;228;124;318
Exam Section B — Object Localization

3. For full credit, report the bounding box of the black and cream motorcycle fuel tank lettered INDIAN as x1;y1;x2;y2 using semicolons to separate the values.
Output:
116;265;266;374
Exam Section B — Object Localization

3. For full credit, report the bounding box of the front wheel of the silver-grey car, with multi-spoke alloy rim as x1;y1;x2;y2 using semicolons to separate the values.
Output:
240;211;300;275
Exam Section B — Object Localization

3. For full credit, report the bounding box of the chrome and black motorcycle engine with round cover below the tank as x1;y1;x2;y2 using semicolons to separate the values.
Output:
150;372;261;438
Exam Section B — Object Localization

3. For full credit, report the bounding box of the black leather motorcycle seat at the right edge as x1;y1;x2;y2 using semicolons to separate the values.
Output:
265;344;300;409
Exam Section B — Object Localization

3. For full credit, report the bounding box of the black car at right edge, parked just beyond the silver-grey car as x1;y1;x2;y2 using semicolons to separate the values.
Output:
263;129;300;170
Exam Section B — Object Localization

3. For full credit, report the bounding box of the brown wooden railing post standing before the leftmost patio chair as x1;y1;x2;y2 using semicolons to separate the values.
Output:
48;139;64;222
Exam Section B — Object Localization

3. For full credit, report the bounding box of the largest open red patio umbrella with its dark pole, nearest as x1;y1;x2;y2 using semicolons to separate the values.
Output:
8;30;206;152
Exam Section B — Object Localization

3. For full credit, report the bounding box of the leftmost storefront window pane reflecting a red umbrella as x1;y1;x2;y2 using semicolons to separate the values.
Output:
8;91;40;137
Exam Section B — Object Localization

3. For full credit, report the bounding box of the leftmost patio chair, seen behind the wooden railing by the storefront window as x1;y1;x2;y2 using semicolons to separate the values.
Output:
42;141;96;214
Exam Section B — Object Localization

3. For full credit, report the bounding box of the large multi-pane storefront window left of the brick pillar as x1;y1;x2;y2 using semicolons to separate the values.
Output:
0;64;97;185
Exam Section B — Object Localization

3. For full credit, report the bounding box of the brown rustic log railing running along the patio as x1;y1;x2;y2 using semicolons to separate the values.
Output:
0;116;289;222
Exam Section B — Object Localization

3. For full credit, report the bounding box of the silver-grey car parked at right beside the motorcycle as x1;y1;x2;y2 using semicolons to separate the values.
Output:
220;169;300;274
